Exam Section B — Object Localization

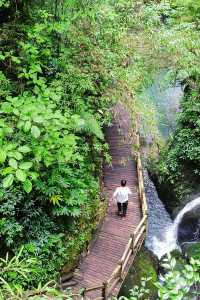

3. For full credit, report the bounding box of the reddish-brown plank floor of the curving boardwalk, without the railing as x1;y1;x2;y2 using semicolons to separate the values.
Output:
71;105;142;300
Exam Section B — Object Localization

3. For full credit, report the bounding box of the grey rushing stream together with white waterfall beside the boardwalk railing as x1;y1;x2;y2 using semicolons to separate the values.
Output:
145;180;200;259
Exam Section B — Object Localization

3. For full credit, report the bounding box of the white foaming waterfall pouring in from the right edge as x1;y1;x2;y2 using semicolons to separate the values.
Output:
151;197;200;259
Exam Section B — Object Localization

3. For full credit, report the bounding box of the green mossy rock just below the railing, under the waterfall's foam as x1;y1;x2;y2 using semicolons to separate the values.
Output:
119;248;158;299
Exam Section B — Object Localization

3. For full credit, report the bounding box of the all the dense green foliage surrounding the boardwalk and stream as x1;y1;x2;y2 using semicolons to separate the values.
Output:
0;0;200;299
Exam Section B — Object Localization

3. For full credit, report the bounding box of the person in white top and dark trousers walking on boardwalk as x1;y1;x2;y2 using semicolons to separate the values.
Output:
113;179;132;217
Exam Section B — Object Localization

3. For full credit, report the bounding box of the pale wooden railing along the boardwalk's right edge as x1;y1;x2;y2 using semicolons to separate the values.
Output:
82;122;148;300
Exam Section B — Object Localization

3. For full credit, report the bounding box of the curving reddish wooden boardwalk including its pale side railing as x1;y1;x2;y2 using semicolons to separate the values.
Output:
70;104;147;300
